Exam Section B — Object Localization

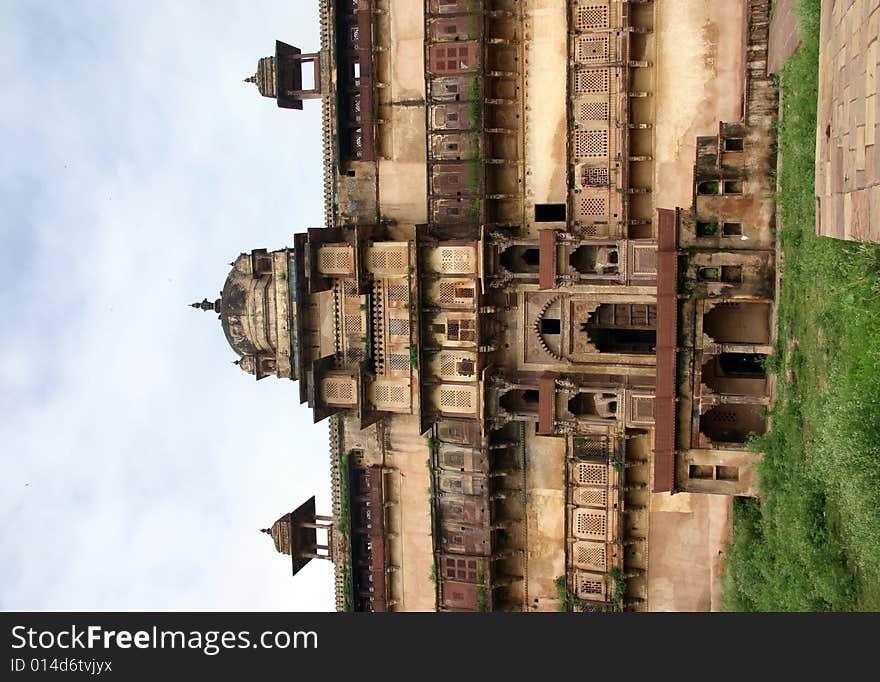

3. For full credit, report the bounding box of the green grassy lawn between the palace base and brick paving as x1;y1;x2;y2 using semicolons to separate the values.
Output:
724;0;880;611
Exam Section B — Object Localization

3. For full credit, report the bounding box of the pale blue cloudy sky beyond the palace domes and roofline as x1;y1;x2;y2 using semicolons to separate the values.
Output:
0;0;334;611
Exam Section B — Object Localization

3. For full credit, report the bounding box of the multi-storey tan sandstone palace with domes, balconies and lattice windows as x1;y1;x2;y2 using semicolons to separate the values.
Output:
193;0;777;611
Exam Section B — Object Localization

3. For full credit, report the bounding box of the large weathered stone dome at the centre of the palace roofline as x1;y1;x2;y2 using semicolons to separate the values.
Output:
219;253;275;358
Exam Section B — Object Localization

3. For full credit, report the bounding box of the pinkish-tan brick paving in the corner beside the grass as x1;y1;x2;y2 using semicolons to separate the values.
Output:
816;0;880;243
